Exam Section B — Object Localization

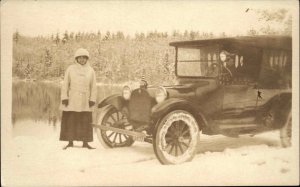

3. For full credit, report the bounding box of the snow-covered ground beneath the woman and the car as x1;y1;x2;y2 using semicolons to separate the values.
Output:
1;121;299;186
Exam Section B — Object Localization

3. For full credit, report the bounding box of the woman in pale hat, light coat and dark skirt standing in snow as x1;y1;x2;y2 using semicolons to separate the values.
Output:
60;48;97;149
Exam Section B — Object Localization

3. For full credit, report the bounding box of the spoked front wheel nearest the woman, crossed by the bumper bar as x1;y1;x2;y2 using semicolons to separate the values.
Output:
95;105;134;148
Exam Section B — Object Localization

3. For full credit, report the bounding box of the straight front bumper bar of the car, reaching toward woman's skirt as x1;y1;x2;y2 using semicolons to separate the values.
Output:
92;124;148;143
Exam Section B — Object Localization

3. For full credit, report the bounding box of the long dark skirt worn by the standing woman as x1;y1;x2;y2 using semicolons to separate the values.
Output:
59;111;93;142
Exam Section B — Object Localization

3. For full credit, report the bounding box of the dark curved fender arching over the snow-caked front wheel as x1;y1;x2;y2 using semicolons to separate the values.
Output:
151;98;207;129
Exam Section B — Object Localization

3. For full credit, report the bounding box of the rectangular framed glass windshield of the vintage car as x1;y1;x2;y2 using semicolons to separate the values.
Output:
177;46;219;77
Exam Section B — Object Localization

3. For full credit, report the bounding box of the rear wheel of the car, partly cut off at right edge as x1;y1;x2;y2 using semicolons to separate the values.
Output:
280;112;292;147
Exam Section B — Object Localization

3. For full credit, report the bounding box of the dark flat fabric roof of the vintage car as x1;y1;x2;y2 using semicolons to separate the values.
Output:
170;36;292;50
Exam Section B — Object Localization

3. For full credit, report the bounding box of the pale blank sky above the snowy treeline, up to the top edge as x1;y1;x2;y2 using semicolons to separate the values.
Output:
1;0;296;36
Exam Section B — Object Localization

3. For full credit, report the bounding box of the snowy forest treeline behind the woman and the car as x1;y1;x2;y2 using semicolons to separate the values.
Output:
13;31;226;84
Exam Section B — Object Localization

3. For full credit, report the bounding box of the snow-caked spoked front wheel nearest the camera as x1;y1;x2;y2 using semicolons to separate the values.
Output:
153;110;199;164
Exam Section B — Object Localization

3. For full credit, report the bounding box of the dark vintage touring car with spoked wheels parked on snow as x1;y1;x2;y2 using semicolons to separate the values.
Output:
94;36;292;164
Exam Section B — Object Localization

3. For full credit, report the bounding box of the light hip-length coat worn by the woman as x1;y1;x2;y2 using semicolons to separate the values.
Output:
60;63;97;112
